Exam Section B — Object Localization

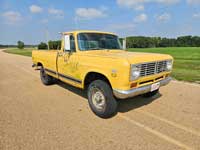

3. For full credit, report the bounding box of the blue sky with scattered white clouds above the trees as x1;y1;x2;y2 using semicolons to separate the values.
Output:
0;0;200;44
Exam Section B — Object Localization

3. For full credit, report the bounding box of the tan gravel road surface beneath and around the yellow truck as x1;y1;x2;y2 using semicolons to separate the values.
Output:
0;51;200;150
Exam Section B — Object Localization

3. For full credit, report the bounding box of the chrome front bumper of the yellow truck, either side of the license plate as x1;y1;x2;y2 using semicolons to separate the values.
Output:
113;77;172;99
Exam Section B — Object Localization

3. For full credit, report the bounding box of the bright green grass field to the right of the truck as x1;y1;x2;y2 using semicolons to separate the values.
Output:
129;47;200;83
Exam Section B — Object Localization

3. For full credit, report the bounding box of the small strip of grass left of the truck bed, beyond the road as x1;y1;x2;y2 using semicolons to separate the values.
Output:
4;48;33;57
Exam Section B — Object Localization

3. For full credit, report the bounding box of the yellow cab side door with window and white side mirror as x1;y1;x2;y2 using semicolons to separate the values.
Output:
57;34;81;87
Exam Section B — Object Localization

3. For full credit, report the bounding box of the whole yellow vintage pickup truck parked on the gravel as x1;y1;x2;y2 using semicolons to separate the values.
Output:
32;31;173;118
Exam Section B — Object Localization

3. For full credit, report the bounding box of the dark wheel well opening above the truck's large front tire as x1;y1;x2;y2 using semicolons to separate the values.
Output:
84;72;112;88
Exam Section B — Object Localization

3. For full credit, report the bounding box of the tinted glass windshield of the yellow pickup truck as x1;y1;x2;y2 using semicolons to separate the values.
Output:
78;33;122;51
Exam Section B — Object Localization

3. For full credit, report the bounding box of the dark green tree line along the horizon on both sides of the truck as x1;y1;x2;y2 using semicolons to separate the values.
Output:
0;35;200;49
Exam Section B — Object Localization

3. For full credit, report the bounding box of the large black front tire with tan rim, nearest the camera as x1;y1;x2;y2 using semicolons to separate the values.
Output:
87;80;118;118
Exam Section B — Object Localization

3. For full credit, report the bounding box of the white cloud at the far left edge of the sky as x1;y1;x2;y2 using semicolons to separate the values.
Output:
2;11;22;24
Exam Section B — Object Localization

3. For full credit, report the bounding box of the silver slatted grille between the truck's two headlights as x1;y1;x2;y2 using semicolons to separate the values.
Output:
140;61;167;77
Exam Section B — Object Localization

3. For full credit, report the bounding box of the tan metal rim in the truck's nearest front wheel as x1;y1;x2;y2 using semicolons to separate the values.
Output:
91;87;106;110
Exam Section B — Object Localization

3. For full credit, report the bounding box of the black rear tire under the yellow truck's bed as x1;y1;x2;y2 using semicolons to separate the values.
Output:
40;67;55;85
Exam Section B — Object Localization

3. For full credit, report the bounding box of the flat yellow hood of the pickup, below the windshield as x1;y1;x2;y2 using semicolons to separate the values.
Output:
81;50;172;64
